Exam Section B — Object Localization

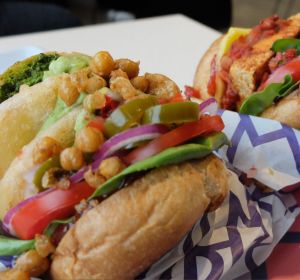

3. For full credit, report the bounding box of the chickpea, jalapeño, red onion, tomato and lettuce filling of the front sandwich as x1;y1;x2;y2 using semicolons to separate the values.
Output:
0;52;228;276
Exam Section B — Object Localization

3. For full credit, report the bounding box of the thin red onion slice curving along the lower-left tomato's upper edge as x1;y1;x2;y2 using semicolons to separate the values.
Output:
2;189;54;236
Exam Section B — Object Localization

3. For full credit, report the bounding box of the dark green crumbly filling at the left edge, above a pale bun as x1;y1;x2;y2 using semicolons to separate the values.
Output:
0;53;59;103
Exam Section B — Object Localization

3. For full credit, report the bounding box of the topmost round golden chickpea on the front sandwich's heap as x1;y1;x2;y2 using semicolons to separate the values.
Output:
91;51;115;77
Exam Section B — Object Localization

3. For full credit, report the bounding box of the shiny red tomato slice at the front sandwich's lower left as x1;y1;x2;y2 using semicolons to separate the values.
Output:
12;181;95;240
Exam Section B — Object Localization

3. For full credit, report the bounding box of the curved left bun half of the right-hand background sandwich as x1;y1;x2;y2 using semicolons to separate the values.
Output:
194;35;224;100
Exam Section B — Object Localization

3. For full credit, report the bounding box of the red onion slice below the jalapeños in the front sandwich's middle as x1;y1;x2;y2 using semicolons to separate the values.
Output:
70;124;169;183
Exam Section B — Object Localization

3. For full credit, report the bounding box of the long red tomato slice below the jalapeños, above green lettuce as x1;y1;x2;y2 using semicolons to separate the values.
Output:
124;116;224;164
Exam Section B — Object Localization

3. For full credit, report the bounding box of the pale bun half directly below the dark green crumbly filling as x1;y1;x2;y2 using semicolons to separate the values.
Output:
0;78;58;179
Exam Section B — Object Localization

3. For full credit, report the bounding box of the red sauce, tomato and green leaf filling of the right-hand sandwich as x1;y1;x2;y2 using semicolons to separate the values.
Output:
208;16;299;115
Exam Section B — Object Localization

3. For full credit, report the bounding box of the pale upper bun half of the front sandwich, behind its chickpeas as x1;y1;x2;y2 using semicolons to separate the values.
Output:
0;108;80;219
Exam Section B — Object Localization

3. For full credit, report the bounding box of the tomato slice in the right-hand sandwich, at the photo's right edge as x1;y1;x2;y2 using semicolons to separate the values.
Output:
259;56;300;90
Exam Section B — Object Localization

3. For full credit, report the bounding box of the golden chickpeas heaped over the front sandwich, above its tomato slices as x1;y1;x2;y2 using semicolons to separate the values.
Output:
34;51;179;188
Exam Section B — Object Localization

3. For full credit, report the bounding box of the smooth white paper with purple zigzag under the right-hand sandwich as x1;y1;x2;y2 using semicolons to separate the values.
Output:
219;111;300;190
